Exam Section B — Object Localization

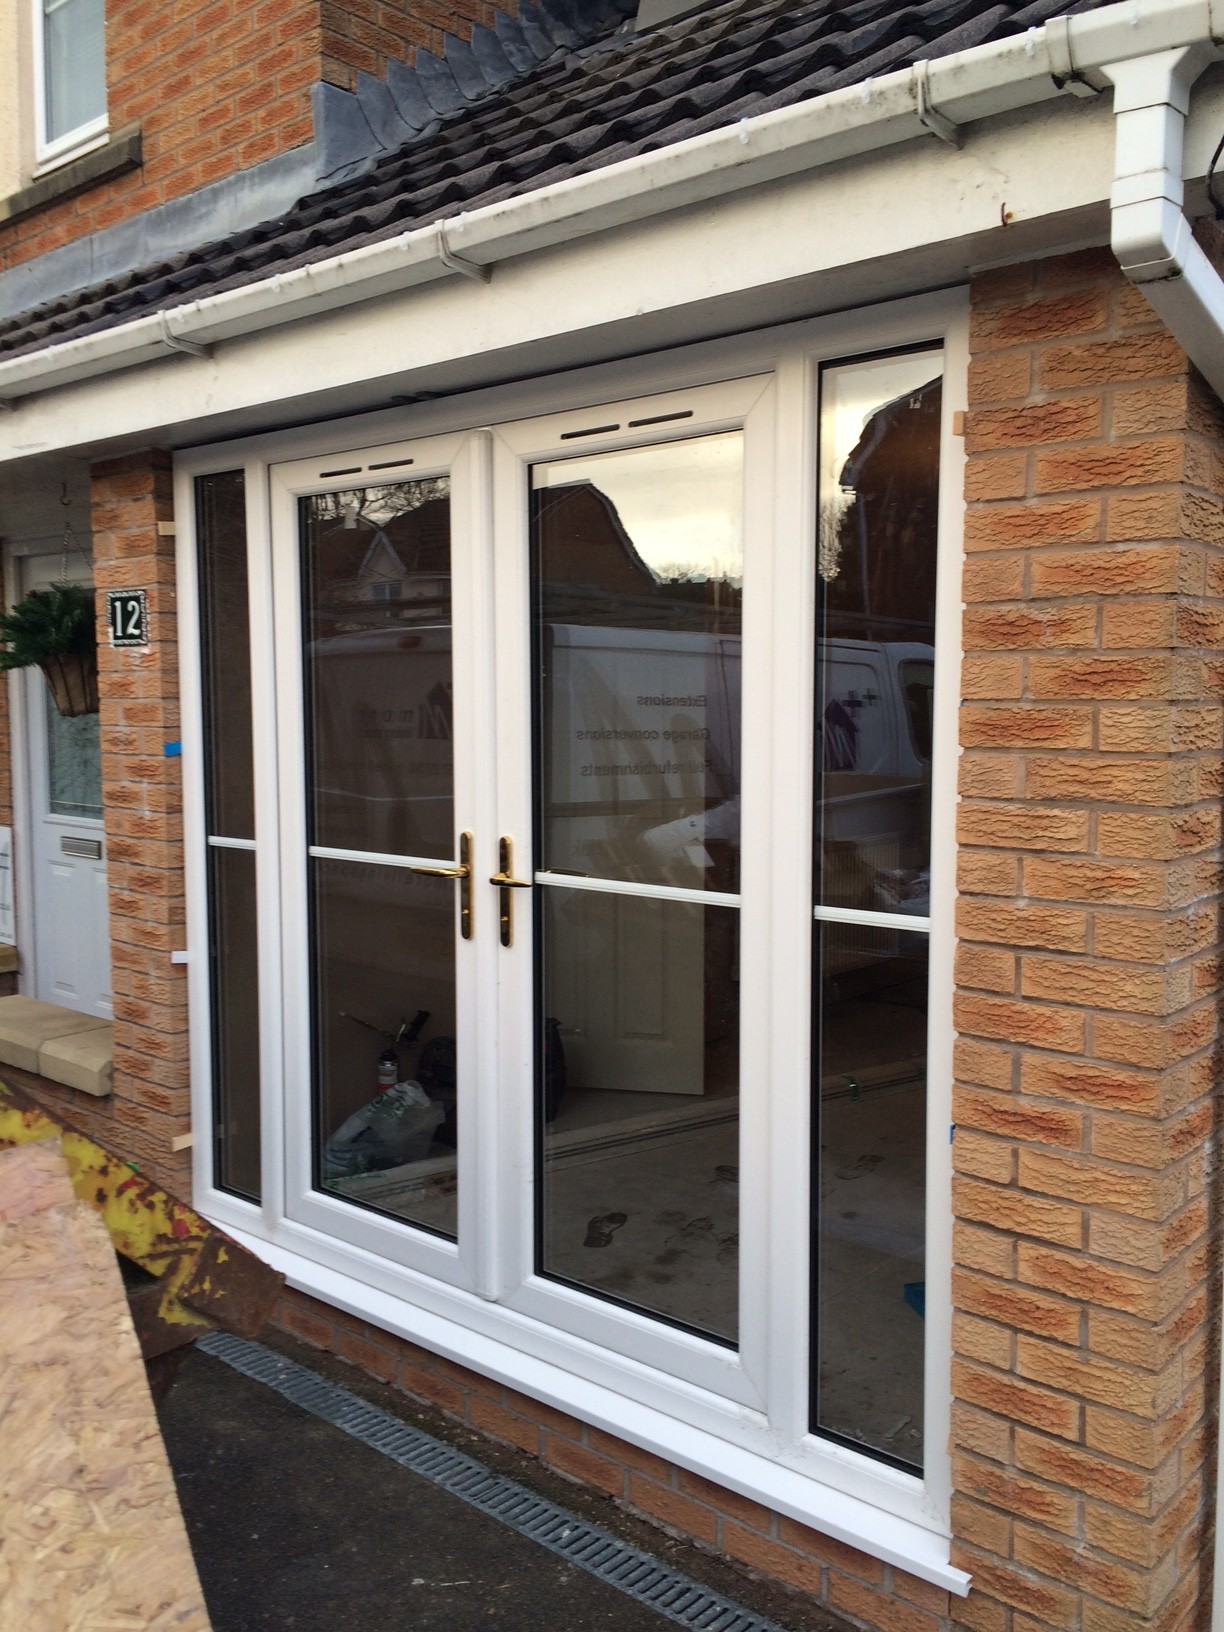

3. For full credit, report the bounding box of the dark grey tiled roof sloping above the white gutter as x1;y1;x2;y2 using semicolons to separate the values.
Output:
0;0;1105;356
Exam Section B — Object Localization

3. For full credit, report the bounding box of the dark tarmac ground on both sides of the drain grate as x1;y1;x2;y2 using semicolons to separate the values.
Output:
158;1345;839;1632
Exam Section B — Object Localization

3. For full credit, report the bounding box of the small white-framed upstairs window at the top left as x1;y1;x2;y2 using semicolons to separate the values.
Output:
34;0;106;163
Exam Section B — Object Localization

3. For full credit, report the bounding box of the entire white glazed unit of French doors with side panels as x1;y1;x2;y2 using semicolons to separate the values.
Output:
181;300;963;1580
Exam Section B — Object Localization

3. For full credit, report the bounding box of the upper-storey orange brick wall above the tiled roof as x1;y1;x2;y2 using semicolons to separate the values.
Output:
0;0;519;271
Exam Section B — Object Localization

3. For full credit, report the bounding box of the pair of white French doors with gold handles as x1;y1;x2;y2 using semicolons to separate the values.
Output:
271;377;774;1408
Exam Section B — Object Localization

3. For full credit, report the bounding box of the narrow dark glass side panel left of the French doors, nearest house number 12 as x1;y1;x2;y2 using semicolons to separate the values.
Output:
196;470;259;1201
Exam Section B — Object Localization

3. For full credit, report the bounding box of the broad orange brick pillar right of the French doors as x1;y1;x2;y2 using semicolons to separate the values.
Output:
953;241;1224;1632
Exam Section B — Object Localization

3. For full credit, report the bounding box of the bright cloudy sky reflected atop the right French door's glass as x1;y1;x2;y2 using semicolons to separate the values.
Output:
532;431;744;584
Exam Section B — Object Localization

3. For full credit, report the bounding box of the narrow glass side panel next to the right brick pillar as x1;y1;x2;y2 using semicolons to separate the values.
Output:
813;351;942;1467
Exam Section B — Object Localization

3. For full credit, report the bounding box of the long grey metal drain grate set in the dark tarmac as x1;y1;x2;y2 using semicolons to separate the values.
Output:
197;1332;796;1632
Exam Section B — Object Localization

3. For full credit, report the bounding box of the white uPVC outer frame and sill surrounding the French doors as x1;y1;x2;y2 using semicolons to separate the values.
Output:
176;290;968;1593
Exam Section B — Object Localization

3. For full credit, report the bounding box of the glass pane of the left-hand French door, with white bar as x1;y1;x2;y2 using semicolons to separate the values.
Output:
300;478;457;1239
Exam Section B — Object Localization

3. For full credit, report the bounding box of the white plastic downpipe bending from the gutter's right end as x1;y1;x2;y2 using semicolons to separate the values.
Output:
1102;38;1224;1632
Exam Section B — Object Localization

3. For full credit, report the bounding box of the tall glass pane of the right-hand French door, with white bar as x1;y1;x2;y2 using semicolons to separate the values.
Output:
532;431;744;1345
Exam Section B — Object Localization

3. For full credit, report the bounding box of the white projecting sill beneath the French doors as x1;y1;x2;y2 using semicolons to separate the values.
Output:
224;1221;969;1598
